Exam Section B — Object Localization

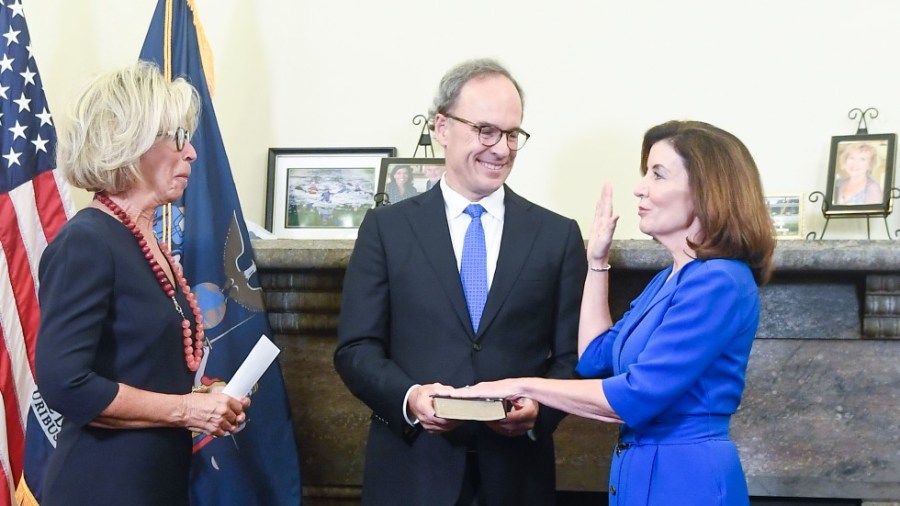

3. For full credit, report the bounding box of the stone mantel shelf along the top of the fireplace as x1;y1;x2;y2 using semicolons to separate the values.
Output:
253;239;900;272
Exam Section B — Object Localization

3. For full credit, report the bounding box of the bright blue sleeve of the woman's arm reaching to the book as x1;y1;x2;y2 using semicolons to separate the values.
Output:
603;266;748;427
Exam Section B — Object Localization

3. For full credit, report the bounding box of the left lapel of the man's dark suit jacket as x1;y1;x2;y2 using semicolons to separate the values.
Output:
405;185;474;339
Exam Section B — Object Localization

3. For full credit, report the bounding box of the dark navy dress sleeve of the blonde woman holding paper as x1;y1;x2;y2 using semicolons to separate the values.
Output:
35;223;119;426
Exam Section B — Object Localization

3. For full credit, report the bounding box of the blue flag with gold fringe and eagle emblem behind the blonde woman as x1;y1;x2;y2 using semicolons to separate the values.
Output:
140;0;301;506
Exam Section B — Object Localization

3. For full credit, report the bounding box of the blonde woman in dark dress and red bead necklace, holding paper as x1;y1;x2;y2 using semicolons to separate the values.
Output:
34;62;250;506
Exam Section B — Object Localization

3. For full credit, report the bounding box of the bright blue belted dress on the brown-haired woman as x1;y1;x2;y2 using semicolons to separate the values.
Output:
577;259;759;505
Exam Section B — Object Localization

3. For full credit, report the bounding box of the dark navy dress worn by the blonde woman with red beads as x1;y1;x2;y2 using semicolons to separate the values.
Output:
35;208;193;506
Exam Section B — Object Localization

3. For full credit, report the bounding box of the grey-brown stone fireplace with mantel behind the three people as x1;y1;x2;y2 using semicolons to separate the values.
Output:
253;239;900;504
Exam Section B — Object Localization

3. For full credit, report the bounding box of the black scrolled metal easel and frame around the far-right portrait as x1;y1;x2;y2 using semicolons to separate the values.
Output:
806;107;900;240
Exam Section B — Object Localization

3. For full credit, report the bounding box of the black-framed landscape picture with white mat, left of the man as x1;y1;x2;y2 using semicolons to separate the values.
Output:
266;148;397;239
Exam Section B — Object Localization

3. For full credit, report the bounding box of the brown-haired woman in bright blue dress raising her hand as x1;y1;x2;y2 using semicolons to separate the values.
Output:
454;121;775;506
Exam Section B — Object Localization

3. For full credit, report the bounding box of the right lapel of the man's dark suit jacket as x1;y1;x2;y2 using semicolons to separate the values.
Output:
476;187;540;339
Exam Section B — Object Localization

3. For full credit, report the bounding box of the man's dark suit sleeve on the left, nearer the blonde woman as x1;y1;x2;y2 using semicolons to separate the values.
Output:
334;210;415;437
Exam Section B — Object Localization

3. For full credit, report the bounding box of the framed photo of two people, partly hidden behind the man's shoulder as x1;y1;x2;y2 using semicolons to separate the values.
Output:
375;158;445;205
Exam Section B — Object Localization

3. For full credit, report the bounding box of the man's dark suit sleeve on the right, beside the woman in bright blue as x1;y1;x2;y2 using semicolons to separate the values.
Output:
537;220;587;433
